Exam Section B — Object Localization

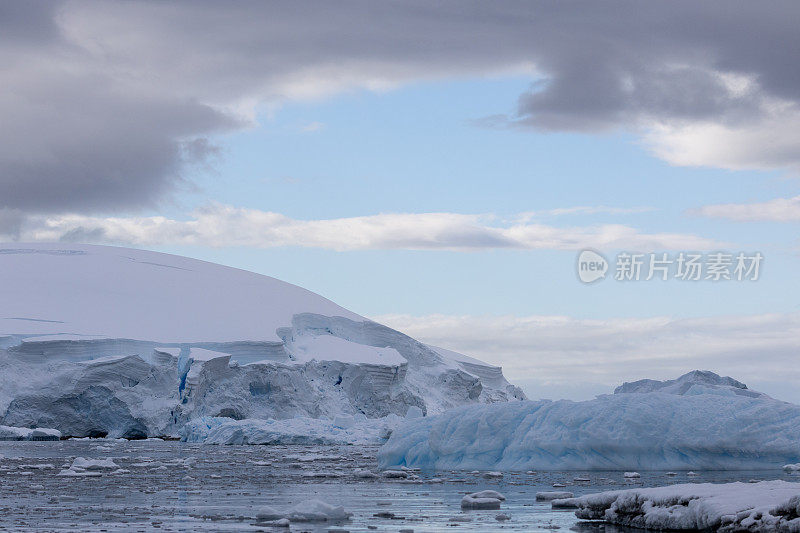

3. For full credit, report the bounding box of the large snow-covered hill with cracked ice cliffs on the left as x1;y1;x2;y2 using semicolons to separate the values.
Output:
0;244;524;437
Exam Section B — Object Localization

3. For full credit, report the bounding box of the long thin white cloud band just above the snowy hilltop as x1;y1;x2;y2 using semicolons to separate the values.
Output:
0;204;722;251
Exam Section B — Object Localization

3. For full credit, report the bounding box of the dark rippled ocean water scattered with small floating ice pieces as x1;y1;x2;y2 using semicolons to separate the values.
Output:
0;439;796;533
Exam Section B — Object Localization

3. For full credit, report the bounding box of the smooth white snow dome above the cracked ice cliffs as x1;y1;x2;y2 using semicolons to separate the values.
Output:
0;243;356;342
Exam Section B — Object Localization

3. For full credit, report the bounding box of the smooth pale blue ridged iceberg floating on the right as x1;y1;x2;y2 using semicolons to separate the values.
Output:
378;372;800;470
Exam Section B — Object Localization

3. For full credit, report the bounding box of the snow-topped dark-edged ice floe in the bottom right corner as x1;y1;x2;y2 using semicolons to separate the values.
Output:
558;481;800;532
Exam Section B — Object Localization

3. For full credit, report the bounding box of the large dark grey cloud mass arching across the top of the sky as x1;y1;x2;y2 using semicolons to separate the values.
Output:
0;0;800;212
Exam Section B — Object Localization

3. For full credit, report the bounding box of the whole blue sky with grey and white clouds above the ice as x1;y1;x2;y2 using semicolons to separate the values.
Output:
0;1;800;402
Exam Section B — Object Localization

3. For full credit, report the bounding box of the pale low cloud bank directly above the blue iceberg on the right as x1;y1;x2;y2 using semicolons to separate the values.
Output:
372;313;800;401
